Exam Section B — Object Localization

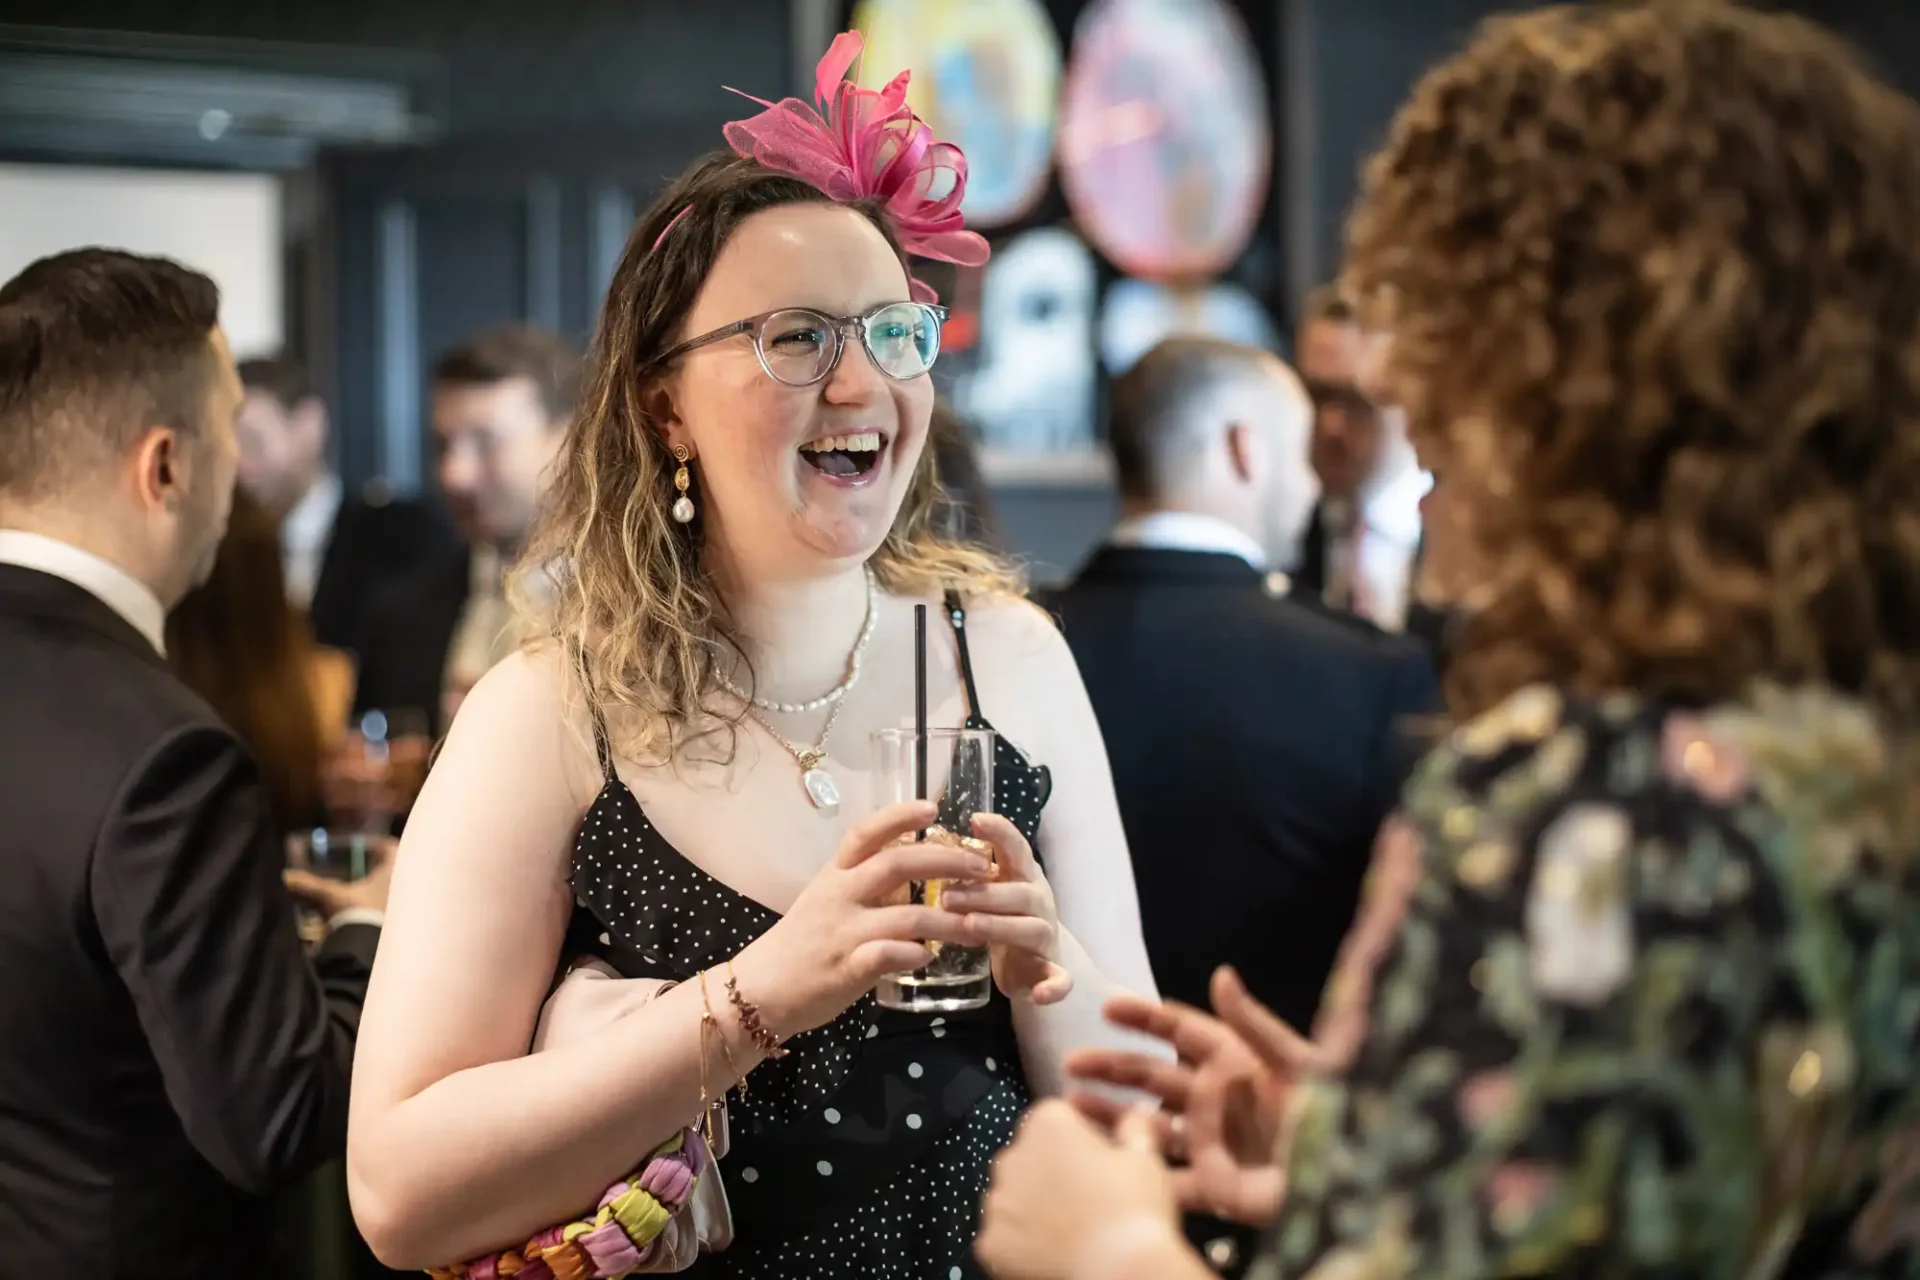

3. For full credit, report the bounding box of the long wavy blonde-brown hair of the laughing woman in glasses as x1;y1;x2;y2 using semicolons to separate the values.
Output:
515;152;1023;764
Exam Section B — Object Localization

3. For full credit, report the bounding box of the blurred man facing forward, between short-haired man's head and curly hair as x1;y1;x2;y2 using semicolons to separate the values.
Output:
1292;284;1427;631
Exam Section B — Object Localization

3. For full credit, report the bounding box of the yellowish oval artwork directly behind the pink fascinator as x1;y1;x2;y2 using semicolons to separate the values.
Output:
852;0;1060;228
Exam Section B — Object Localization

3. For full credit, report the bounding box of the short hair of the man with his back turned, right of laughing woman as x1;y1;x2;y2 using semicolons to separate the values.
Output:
1108;334;1273;499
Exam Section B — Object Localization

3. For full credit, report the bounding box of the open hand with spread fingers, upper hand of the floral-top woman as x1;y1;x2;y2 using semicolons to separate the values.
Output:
1068;967;1327;1226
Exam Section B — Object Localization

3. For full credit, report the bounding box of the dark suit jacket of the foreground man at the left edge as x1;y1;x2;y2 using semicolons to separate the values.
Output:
0;566;378;1280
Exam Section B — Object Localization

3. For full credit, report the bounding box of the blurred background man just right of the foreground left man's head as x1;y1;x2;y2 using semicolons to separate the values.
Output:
236;355;451;651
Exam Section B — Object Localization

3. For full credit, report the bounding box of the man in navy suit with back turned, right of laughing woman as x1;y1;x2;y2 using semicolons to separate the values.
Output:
1041;338;1436;1270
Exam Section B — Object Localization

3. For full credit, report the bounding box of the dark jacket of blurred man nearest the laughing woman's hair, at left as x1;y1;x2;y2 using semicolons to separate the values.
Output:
353;547;472;741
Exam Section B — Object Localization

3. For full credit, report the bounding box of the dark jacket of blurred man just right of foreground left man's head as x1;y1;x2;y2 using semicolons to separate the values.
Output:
307;489;453;651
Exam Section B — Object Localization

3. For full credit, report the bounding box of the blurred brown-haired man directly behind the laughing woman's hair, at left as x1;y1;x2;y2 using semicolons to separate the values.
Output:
353;326;580;739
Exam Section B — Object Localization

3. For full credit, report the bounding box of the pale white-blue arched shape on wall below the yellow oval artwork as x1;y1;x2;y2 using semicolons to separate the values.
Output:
952;226;1098;453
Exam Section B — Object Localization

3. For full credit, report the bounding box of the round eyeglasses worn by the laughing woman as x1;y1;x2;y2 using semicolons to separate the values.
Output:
659;301;947;386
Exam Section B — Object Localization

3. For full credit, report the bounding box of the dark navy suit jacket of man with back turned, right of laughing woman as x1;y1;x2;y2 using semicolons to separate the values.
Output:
1041;547;1436;1031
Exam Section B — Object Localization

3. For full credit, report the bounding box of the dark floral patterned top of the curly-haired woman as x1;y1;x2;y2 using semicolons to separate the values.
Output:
1252;689;1920;1280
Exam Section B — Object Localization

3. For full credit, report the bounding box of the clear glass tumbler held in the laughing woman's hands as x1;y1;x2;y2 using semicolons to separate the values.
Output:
874;729;993;1013
